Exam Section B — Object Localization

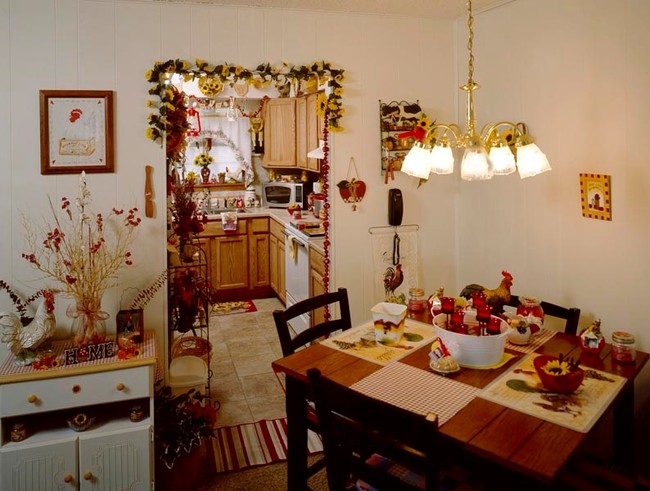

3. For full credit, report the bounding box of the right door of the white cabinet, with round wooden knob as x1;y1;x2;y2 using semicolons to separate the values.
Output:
79;426;151;491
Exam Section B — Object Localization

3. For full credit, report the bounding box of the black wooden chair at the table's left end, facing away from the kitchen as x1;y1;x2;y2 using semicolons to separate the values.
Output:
273;288;352;486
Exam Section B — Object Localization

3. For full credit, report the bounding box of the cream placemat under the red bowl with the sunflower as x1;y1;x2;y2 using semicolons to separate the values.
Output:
478;353;626;433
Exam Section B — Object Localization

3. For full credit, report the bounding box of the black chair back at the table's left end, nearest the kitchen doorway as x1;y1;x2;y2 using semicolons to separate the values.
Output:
273;288;352;356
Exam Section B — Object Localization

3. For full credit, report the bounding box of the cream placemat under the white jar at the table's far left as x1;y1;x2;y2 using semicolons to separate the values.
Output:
321;319;436;365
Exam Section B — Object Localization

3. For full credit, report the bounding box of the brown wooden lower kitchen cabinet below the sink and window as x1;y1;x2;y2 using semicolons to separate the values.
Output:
200;217;272;302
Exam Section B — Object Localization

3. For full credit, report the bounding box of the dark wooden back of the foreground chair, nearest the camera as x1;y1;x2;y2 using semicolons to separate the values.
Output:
307;368;441;490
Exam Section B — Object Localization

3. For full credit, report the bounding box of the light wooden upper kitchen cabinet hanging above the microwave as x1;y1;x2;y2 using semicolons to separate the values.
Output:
262;93;323;172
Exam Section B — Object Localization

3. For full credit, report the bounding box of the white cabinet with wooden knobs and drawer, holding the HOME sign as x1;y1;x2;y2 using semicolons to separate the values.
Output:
0;331;157;491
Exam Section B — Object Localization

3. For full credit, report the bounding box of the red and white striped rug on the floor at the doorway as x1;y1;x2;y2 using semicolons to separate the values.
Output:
209;418;323;472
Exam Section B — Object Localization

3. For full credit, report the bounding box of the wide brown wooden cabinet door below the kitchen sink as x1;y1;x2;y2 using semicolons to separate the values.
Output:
211;235;248;291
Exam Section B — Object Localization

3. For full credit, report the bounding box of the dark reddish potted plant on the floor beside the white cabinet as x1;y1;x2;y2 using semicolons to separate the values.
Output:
154;383;216;490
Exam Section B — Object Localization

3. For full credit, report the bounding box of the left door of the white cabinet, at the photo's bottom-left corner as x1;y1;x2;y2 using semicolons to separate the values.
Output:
0;436;76;491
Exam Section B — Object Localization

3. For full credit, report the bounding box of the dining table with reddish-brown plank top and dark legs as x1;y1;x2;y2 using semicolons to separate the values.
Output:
273;313;649;490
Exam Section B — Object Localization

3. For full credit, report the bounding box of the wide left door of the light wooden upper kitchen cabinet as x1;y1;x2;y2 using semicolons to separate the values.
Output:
262;97;296;167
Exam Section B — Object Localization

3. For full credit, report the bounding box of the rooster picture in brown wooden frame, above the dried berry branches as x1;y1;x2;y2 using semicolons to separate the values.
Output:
39;90;115;174
